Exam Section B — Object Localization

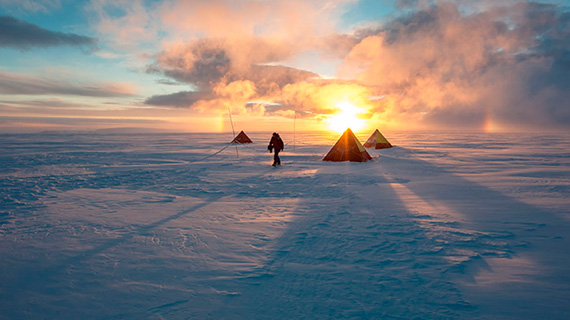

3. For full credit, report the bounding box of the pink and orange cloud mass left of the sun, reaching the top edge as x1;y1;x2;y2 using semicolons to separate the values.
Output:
92;0;347;112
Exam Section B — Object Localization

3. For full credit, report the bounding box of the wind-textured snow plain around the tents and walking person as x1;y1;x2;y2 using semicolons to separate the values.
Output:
0;132;570;319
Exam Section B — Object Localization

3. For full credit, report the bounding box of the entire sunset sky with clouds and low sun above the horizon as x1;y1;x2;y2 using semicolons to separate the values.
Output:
0;0;570;133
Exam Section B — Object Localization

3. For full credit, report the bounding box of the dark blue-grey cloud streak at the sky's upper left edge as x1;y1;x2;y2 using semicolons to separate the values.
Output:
0;16;97;50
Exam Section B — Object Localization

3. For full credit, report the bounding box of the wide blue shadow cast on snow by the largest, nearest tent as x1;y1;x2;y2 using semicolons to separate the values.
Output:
216;159;476;319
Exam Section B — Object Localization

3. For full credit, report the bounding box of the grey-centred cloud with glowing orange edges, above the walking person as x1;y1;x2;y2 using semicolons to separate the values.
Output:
145;39;318;110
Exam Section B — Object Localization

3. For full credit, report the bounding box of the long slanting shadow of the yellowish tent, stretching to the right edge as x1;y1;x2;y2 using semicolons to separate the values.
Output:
382;148;568;236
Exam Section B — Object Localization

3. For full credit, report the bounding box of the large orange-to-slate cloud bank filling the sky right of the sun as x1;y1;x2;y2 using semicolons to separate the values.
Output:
341;1;570;128
